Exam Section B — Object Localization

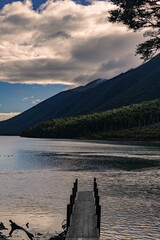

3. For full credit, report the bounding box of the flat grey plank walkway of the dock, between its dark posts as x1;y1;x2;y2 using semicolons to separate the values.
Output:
66;191;99;240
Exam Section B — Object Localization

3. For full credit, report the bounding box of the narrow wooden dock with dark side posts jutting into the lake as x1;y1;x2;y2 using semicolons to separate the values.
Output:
66;179;101;240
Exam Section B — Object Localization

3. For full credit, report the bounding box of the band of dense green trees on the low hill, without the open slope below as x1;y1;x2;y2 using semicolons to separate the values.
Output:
21;99;160;138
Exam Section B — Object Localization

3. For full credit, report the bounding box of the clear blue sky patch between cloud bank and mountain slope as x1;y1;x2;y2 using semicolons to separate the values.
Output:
0;82;68;113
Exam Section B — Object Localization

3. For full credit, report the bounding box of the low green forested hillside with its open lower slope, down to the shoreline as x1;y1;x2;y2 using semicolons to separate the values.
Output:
22;99;160;140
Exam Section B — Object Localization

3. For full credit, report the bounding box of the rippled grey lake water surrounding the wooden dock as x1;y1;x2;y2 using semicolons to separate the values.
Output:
0;137;160;240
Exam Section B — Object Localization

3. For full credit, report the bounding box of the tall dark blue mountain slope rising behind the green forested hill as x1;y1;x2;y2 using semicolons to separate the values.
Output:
0;54;160;135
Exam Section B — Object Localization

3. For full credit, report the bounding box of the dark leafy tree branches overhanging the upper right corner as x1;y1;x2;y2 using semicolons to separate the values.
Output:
109;0;160;61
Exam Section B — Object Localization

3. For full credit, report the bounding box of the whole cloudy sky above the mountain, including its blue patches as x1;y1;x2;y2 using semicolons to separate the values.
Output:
0;0;144;121
